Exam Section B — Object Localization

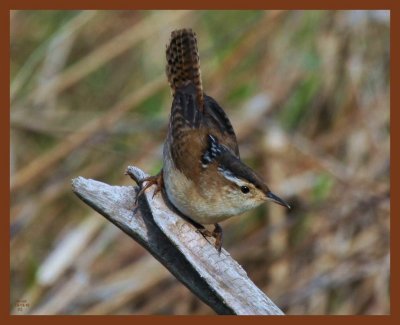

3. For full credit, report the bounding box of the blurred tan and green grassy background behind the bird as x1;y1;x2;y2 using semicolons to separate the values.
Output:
10;11;390;314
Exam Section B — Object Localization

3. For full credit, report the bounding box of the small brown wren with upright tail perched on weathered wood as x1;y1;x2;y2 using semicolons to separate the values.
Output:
138;29;290;251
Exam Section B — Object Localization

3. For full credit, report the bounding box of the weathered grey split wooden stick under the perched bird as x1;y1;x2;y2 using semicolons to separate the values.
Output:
72;167;283;315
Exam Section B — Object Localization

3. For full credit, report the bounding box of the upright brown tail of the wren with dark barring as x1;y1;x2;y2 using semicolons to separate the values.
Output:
166;29;204;109
